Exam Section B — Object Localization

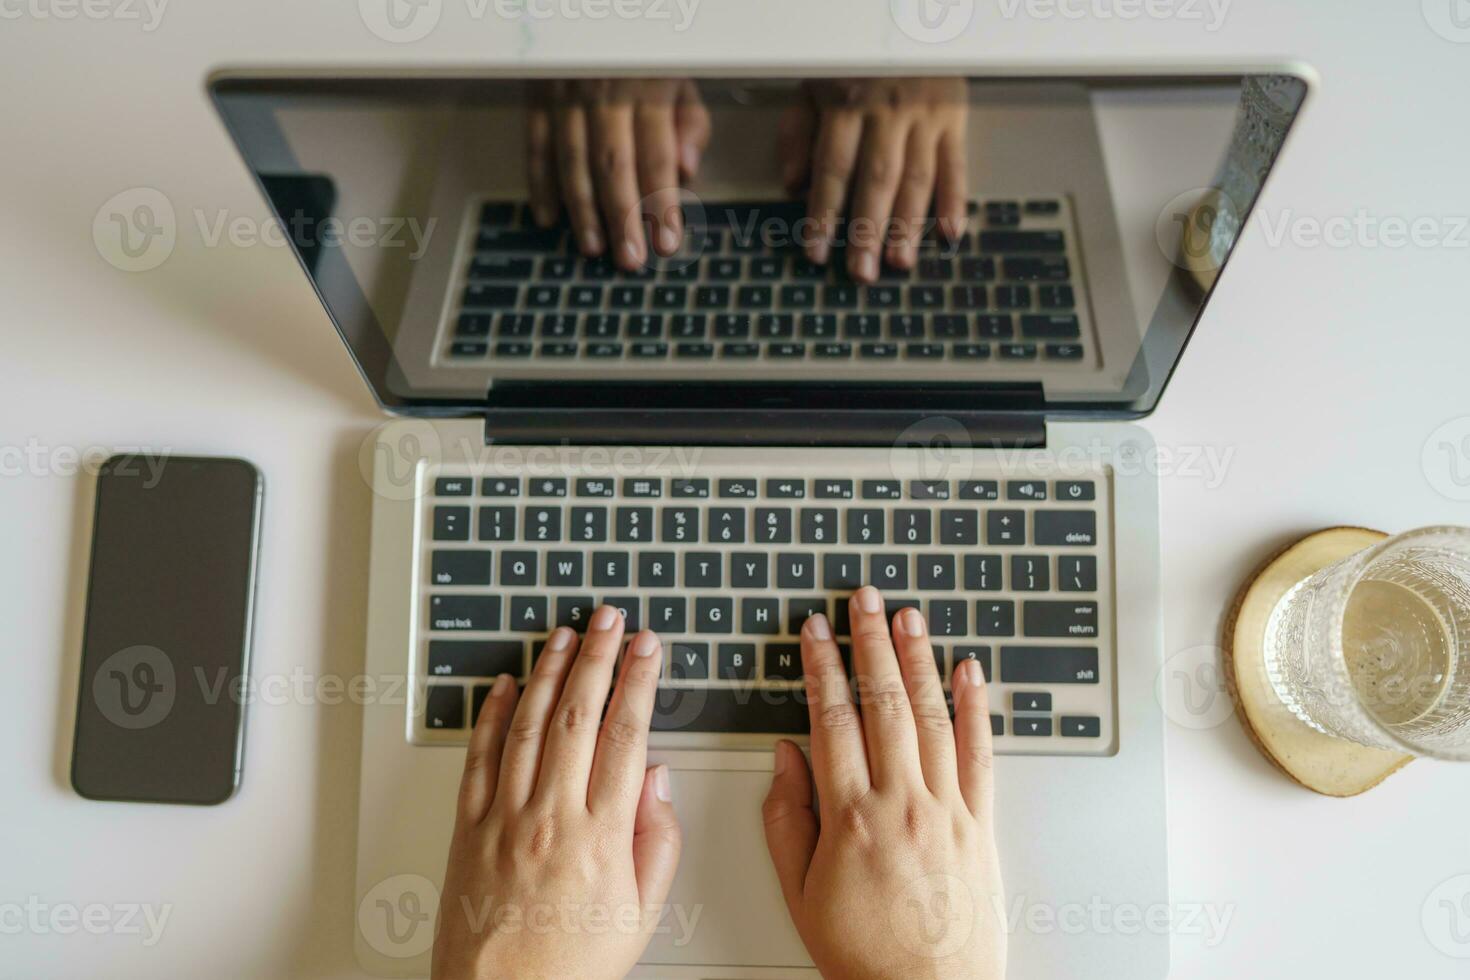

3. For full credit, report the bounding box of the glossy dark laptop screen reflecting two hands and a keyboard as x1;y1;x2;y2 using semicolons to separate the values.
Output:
213;73;1305;414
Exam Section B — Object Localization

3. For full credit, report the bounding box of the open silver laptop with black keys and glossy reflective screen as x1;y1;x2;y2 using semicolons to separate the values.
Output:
210;68;1308;980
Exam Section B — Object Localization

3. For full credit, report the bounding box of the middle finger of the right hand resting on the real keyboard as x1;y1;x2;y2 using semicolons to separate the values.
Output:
852;585;920;792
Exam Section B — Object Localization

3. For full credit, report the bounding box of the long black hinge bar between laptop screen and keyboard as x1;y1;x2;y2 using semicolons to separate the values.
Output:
485;385;1047;448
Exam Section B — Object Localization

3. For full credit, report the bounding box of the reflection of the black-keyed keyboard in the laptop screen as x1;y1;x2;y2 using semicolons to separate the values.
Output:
441;197;1091;376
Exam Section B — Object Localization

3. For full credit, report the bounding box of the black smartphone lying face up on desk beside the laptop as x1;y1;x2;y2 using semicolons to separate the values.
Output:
72;454;265;804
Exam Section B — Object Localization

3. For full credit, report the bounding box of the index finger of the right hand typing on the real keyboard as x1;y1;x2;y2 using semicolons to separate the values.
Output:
801;614;872;807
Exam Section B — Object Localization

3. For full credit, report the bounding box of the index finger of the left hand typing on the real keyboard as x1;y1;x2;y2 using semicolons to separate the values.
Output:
587;629;663;820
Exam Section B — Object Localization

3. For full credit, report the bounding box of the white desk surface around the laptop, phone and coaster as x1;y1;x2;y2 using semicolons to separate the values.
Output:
0;0;1470;980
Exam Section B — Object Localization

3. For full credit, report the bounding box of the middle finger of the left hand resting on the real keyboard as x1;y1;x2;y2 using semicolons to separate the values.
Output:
535;605;623;807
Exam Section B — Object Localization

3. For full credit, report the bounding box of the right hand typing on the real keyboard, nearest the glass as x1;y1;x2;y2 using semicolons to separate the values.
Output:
764;586;1005;980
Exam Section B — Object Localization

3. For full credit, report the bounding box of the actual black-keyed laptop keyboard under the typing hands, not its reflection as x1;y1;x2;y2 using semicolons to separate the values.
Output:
415;453;1113;754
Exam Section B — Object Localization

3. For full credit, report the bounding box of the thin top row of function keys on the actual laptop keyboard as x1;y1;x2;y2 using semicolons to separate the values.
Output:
434;476;1097;501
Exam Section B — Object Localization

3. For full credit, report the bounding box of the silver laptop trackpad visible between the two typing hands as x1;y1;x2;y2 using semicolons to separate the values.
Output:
642;768;811;967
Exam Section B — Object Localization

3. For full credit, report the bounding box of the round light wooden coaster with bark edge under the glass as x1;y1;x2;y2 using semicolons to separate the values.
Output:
1222;527;1413;796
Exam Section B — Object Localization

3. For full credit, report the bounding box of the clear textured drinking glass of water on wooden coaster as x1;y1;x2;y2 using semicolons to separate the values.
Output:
1264;527;1470;760
